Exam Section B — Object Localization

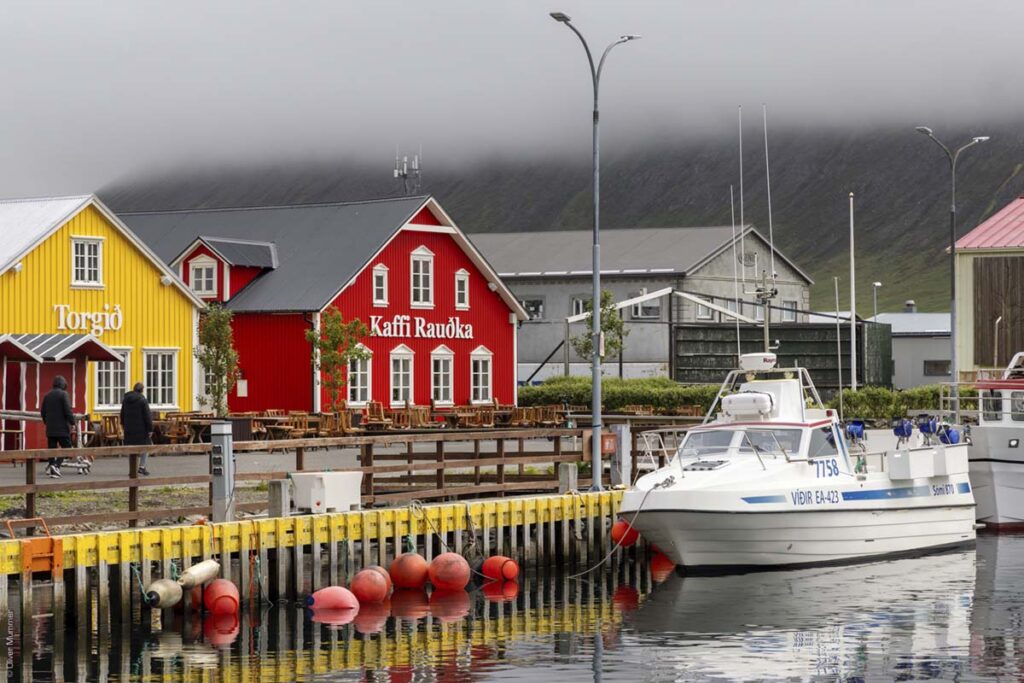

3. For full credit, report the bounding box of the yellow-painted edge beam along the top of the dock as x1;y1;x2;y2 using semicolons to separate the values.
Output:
0;490;623;575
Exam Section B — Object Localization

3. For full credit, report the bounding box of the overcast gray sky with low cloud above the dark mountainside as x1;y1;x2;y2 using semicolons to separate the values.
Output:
0;0;1024;197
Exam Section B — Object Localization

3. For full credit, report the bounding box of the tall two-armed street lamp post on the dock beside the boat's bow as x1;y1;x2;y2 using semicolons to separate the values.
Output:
551;12;640;490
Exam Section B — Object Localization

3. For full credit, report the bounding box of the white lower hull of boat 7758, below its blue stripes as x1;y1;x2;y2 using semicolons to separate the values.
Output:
634;504;976;571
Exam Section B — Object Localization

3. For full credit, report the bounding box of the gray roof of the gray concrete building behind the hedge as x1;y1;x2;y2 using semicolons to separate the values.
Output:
470;225;811;282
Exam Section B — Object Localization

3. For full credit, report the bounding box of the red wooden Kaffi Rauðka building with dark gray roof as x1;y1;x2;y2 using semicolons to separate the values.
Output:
123;197;526;412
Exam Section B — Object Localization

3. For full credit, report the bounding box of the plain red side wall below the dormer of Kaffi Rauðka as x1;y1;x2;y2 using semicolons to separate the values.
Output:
227;313;313;413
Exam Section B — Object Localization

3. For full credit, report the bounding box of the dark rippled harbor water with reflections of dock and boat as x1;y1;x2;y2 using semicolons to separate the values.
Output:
12;536;1024;683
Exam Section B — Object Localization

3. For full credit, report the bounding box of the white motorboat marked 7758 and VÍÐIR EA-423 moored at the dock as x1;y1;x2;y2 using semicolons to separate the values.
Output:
621;353;975;571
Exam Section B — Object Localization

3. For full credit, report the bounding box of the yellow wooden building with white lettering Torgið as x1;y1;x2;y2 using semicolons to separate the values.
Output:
0;196;203;450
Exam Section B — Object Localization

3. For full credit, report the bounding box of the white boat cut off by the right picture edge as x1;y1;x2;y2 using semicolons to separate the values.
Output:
969;352;1024;531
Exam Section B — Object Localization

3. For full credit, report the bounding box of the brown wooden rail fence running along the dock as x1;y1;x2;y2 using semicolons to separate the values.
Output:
0;428;591;527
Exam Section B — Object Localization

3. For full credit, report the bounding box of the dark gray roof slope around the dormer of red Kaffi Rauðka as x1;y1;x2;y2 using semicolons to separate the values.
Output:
121;197;427;311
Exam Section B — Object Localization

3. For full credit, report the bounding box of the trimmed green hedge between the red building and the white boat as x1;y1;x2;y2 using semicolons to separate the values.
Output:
519;376;718;413
